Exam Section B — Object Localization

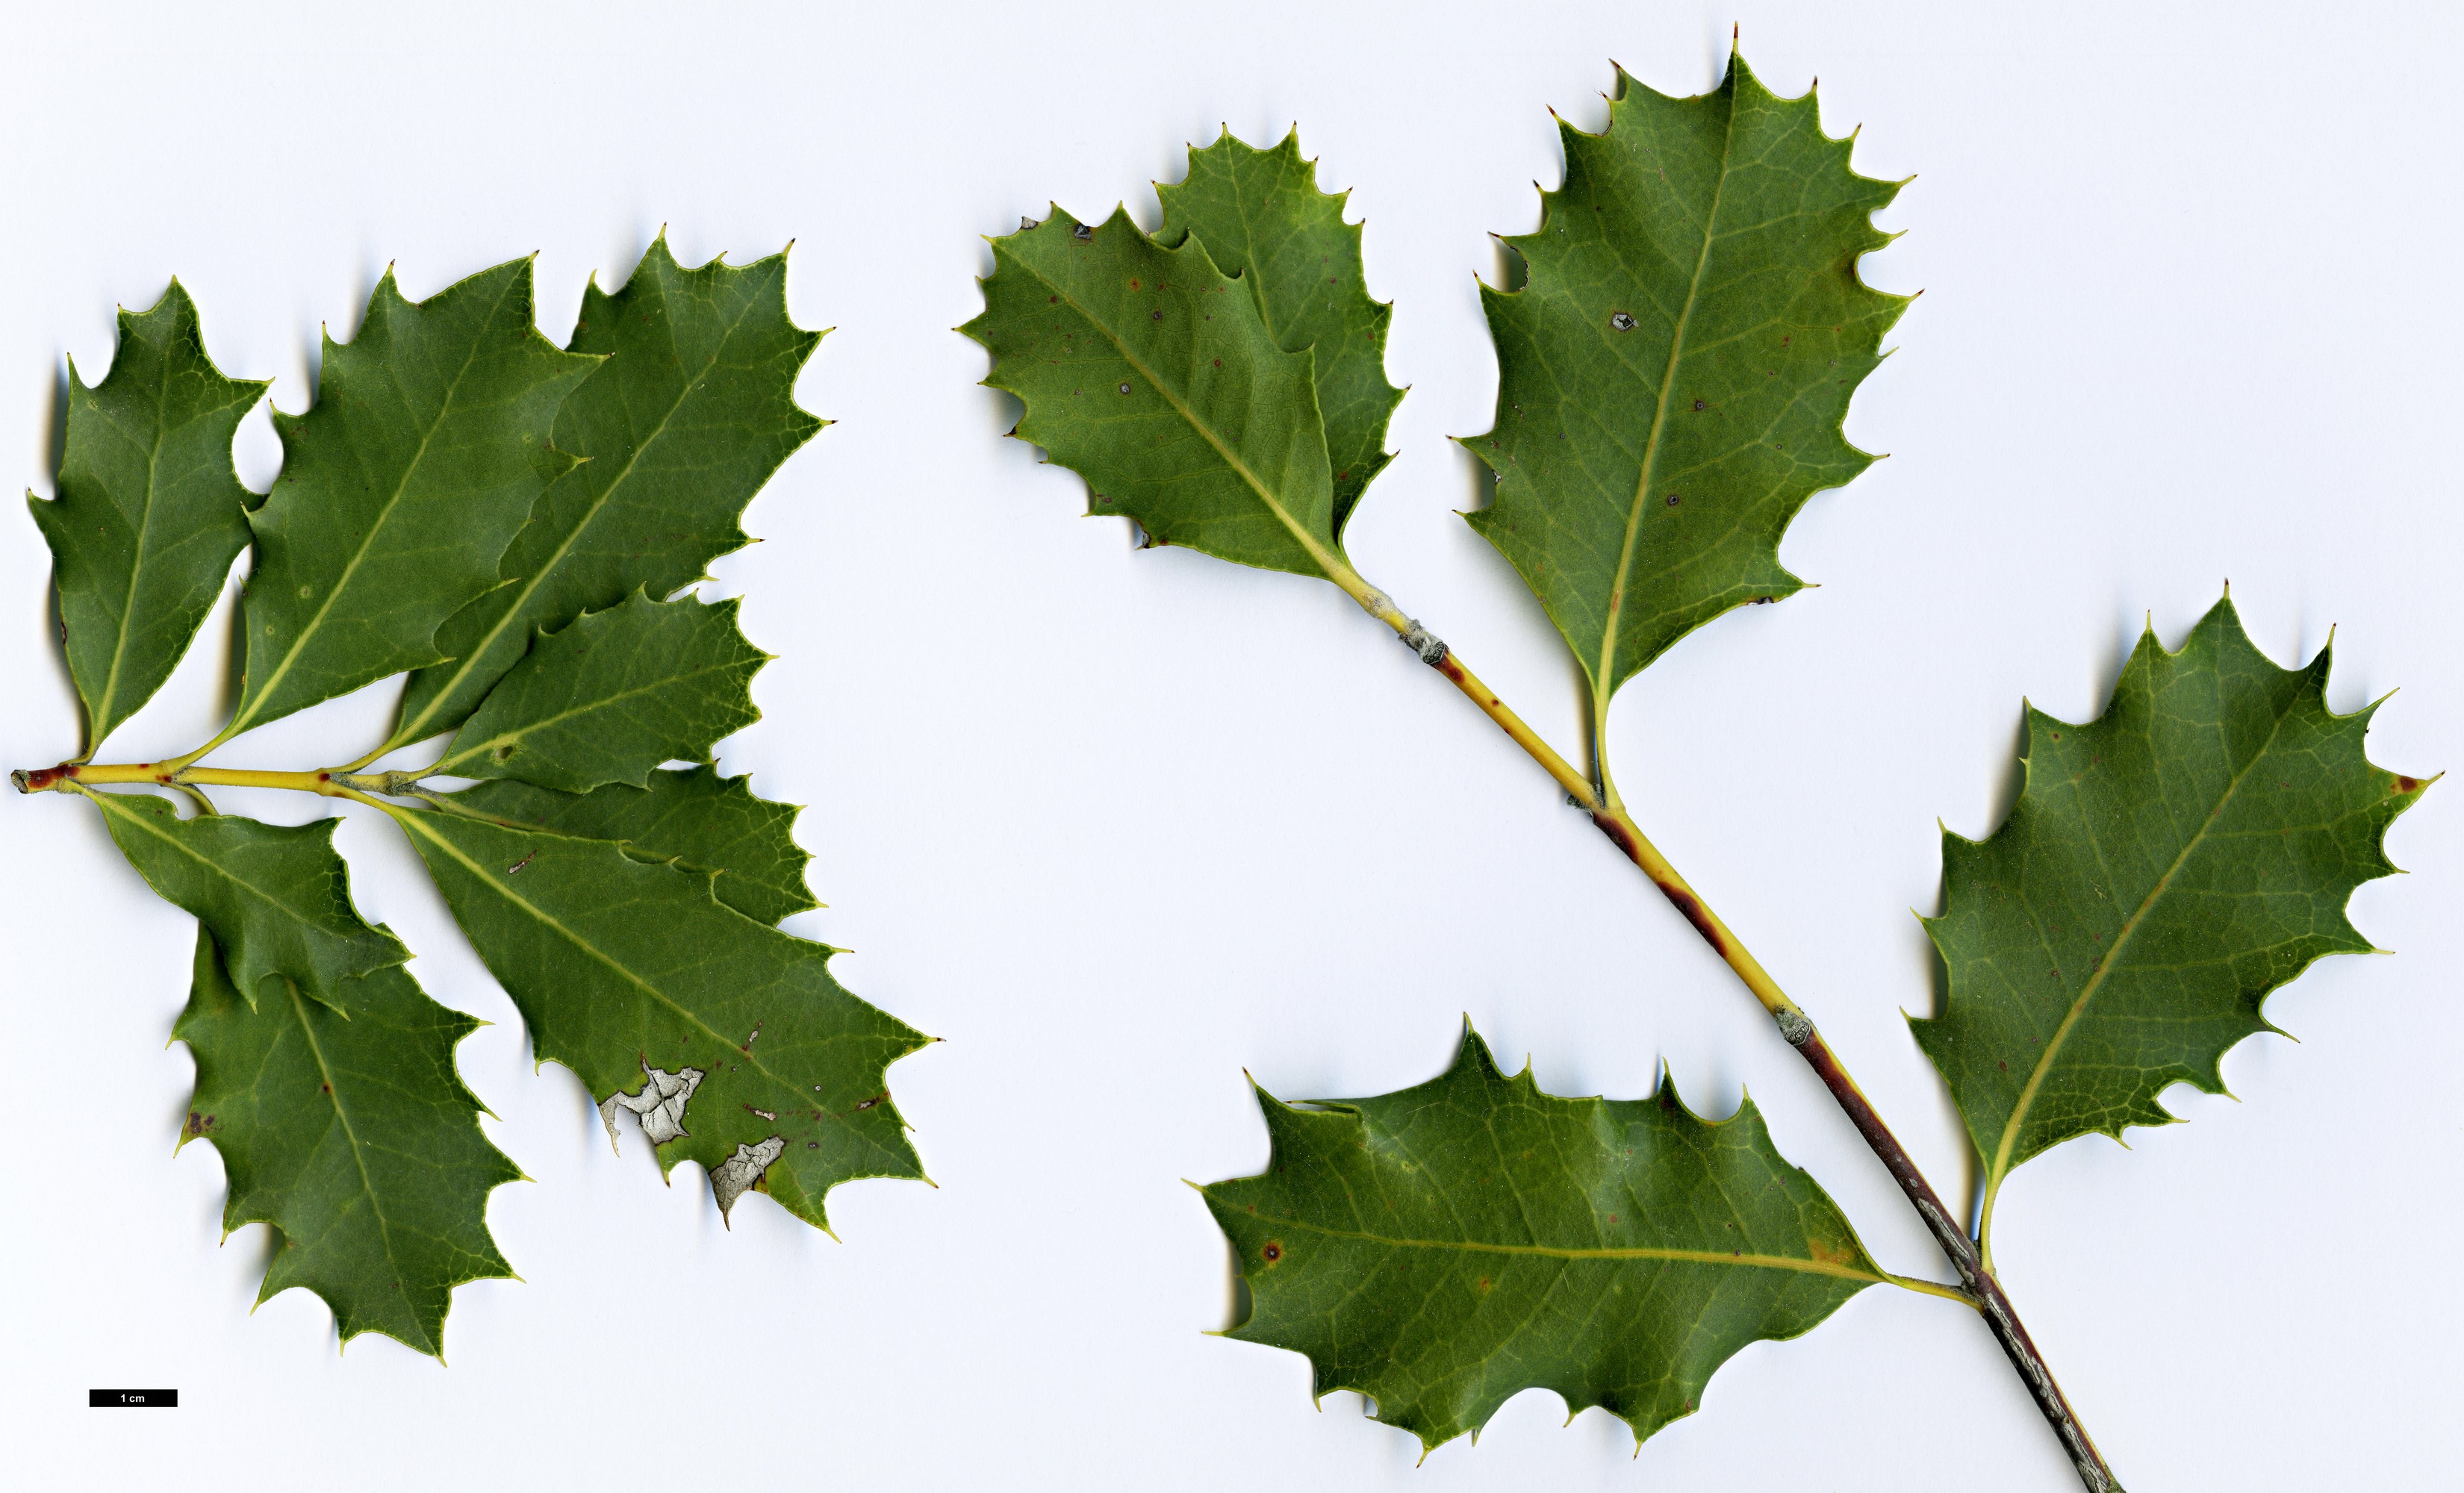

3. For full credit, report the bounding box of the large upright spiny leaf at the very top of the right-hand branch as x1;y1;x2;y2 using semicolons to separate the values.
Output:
1469;54;1907;705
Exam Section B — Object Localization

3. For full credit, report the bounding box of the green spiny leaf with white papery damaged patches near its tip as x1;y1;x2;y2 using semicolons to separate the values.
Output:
394;811;929;1227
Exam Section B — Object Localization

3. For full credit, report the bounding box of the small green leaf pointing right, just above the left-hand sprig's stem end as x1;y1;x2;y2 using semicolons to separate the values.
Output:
434;591;769;794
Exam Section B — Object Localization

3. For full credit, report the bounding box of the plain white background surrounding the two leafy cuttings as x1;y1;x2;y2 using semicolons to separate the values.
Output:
0;0;2464;1493
